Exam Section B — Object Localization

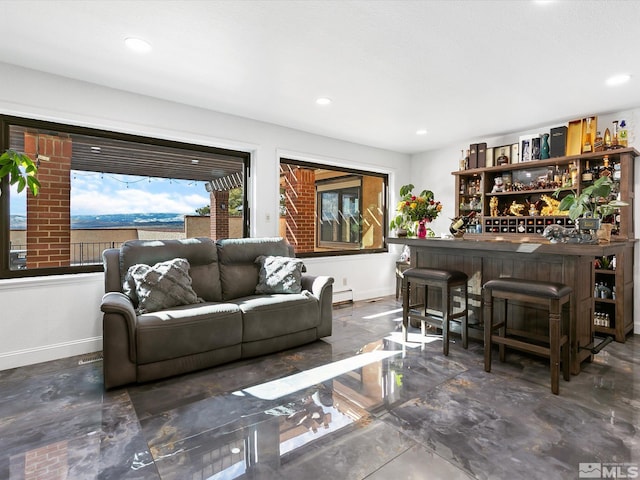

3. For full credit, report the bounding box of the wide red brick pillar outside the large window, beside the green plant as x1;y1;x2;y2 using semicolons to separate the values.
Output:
24;132;72;268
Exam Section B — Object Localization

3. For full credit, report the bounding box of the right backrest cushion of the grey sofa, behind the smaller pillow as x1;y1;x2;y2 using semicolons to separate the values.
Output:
216;237;293;300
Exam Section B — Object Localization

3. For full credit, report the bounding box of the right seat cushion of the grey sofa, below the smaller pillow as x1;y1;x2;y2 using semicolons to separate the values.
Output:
234;290;320;342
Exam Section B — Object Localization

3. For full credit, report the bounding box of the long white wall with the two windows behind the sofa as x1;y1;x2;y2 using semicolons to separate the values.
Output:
0;63;411;370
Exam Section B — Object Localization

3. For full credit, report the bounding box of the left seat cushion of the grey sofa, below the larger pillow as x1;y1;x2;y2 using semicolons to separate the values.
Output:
136;303;242;364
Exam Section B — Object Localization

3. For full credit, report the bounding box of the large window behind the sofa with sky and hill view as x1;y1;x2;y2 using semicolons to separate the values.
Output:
0;116;249;278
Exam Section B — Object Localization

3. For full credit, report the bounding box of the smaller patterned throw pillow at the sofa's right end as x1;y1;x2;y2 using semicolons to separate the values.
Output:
256;255;304;293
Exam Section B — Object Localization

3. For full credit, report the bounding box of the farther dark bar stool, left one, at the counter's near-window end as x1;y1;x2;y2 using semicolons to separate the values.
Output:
402;268;469;355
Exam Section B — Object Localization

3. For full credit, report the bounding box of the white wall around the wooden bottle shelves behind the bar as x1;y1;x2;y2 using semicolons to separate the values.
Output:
411;108;640;334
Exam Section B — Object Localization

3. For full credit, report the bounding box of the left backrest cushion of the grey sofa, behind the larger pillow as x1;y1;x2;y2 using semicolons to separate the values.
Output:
120;237;222;305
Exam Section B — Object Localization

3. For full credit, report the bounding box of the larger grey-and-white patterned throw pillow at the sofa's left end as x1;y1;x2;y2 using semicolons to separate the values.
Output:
125;258;202;314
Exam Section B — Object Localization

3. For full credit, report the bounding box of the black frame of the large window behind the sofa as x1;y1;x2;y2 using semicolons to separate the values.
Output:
0;114;251;279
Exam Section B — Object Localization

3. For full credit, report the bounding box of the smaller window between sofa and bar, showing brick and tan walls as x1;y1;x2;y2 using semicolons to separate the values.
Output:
280;159;387;256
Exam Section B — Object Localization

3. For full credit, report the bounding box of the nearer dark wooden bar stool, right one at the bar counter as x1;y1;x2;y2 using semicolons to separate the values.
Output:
482;278;575;395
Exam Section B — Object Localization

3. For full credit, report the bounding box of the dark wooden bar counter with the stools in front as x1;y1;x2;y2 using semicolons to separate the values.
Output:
387;237;635;375
